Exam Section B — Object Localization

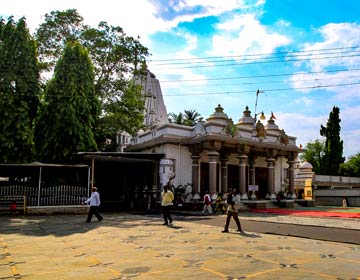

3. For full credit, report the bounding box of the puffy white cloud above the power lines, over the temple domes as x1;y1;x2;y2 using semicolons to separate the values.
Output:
209;14;290;55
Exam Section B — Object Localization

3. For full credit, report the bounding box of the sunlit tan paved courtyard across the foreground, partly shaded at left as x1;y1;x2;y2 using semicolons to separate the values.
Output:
0;213;360;280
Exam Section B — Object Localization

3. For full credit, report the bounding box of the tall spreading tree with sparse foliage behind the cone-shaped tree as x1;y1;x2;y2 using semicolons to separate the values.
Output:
36;9;149;148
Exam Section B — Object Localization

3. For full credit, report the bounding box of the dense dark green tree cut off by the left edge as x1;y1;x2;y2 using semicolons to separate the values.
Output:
0;18;40;163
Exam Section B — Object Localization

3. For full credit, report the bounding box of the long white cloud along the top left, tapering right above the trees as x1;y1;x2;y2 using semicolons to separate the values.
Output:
0;0;264;45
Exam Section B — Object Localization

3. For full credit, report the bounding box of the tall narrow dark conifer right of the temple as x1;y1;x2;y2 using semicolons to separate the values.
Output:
320;106;345;175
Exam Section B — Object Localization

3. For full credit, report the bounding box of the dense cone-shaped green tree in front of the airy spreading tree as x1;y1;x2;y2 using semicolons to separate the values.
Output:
36;42;100;162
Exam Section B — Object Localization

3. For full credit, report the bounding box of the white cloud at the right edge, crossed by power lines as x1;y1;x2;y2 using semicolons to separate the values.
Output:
292;23;360;101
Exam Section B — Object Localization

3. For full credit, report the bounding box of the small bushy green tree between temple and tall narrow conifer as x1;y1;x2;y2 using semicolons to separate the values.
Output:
300;139;325;174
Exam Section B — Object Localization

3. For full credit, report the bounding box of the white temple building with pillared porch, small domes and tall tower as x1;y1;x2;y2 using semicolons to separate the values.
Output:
126;71;302;200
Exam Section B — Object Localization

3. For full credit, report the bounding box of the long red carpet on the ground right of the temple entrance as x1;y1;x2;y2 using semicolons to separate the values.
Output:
251;208;360;219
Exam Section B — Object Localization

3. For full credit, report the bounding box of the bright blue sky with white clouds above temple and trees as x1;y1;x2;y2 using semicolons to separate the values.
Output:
0;0;360;157
